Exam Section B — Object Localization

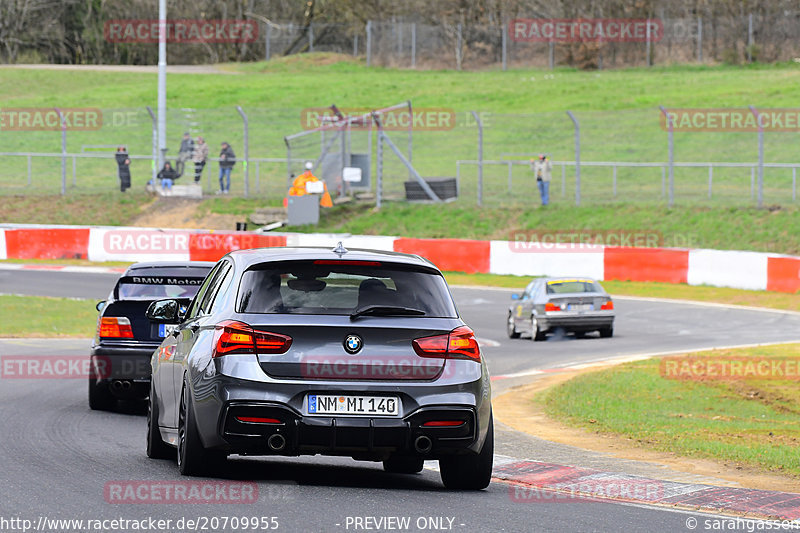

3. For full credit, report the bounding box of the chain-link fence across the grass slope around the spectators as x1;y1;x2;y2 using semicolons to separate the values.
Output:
0;106;800;206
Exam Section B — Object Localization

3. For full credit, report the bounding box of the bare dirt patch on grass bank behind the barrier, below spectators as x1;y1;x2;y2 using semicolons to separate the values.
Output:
130;197;246;230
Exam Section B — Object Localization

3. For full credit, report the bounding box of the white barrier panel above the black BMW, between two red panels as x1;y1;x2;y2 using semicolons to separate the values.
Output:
89;228;191;261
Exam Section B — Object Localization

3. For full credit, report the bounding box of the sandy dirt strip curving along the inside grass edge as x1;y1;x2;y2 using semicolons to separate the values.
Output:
492;367;800;492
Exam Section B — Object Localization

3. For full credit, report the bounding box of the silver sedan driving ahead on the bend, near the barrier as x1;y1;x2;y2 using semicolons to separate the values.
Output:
506;277;614;341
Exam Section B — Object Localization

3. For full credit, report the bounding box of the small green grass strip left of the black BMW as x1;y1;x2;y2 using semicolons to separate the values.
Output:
0;295;97;337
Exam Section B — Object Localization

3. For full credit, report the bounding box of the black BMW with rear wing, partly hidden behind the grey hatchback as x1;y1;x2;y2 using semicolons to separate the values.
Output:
89;261;214;409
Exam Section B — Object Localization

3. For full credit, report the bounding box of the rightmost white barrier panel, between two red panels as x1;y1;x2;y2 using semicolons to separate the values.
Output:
687;250;768;290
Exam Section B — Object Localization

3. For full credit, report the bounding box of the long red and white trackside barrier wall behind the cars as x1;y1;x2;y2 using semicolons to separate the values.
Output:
0;225;800;292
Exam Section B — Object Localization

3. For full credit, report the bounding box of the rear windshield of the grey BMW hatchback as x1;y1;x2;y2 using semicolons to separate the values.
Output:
237;261;458;318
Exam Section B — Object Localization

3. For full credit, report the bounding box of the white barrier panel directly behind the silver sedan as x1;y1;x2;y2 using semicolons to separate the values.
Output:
489;241;604;280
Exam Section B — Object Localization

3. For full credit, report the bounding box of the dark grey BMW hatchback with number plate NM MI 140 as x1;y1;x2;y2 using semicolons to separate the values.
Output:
147;244;494;490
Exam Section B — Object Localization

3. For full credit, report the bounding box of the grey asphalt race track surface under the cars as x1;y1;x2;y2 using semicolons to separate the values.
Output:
0;271;800;532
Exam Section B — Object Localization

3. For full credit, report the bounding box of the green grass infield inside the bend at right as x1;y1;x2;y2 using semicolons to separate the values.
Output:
536;344;800;477
